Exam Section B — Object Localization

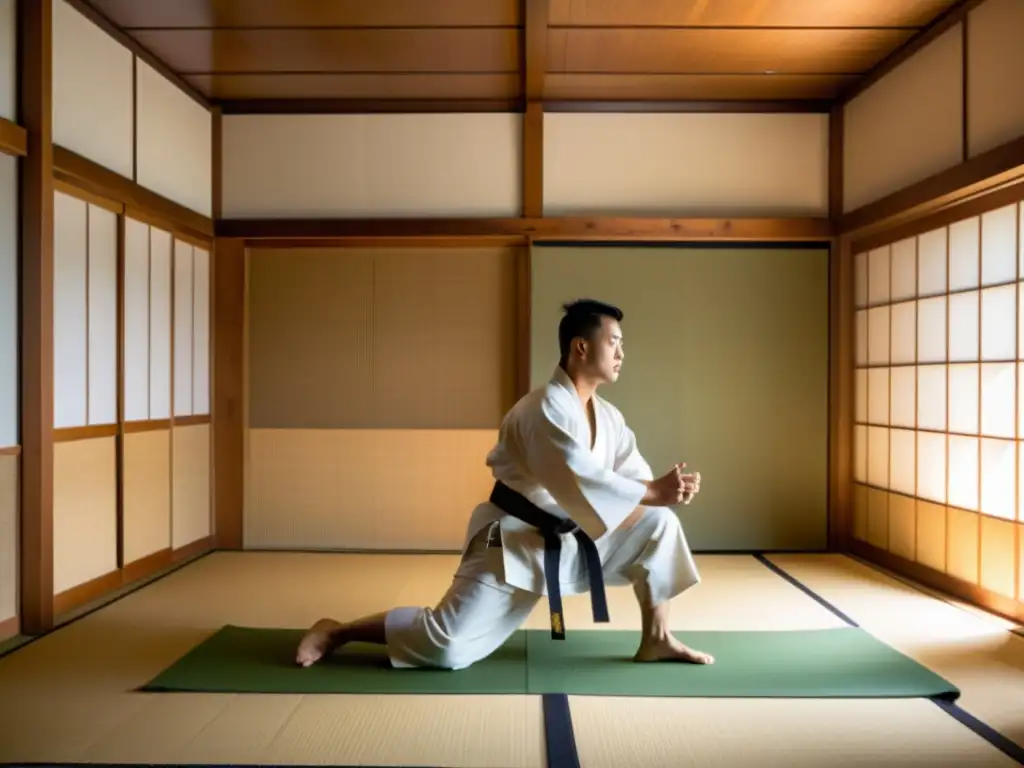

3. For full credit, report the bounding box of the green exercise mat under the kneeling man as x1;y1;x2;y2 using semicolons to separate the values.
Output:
140;626;959;698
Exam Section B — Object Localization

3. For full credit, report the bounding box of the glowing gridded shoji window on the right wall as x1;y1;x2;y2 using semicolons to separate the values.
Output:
851;203;1024;600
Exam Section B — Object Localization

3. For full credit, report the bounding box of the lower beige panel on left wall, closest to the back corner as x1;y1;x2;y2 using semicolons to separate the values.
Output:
171;424;213;549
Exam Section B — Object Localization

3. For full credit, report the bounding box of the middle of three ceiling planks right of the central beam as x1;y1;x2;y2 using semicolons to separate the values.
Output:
548;29;911;75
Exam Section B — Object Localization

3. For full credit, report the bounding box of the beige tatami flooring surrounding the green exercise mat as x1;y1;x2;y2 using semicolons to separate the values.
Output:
0;553;1024;768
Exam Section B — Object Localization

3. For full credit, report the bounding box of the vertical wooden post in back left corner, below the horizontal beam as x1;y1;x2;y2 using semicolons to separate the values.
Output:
211;238;246;549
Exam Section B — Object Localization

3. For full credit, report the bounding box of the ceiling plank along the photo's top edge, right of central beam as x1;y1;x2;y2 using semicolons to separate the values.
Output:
549;0;955;28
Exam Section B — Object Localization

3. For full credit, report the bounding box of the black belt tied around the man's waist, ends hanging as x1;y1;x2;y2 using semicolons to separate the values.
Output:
490;480;608;640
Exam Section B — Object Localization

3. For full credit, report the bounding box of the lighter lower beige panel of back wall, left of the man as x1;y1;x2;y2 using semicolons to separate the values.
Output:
245;429;497;551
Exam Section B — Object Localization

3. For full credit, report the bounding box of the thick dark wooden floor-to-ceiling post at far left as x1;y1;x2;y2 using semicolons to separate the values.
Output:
17;0;53;635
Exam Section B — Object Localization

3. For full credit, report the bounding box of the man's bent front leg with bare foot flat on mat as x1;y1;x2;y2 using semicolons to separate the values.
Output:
598;507;715;664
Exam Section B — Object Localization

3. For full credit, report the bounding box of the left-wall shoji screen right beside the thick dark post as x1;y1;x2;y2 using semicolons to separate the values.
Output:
53;191;118;594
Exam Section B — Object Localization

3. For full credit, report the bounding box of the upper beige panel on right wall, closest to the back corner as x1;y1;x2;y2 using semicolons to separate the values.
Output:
843;25;964;211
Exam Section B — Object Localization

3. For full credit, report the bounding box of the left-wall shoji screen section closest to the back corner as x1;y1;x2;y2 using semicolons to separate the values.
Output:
124;216;211;563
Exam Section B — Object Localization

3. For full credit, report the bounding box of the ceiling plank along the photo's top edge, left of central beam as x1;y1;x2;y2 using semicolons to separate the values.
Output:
91;0;519;30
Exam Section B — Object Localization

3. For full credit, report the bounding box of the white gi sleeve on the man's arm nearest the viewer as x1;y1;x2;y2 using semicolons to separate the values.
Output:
522;399;647;539
